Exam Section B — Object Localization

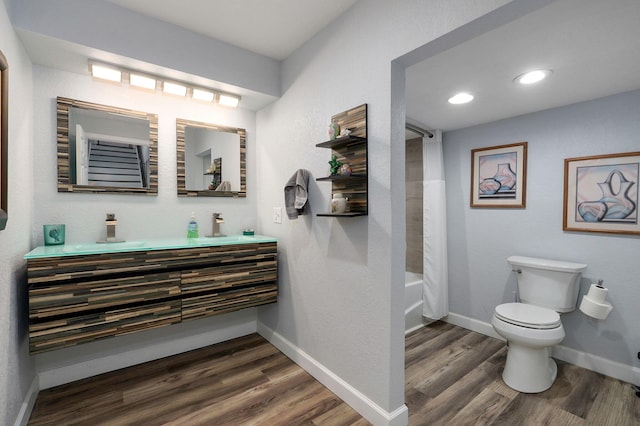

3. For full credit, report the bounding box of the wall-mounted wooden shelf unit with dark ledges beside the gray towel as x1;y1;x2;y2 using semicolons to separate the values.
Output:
316;104;369;217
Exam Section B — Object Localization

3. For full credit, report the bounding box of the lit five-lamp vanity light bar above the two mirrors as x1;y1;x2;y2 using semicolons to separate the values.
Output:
89;61;241;108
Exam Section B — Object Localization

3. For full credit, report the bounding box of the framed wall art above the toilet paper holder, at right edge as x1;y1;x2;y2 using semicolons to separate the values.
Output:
562;152;640;235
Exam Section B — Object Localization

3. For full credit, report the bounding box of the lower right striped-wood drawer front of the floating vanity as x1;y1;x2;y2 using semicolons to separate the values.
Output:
182;283;278;321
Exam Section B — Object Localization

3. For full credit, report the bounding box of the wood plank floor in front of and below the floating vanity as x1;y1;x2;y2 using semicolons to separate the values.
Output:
29;334;368;426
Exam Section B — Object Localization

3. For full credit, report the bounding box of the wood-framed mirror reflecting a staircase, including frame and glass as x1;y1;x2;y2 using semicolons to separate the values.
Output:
57;97;158;195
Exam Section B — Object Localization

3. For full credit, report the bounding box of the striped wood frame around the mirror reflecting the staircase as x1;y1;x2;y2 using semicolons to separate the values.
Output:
56;97;158;195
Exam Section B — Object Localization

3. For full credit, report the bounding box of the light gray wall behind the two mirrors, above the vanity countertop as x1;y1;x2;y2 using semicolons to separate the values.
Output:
32;65;257;246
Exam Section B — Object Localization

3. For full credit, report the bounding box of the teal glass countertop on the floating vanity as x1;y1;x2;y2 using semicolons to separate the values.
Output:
24;235;278;259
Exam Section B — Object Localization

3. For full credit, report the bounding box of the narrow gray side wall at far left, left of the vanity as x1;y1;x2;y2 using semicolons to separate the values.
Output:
0;0;34;425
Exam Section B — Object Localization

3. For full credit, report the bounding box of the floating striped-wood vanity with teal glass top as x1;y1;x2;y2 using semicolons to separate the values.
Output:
25;235;278;354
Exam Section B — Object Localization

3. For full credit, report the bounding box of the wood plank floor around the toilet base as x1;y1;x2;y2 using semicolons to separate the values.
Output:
405;322;640;426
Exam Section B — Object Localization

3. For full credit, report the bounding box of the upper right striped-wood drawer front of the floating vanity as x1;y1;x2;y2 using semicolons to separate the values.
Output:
181;258;278;295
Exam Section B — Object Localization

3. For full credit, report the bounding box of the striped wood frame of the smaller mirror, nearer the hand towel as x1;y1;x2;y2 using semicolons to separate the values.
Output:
176;118;247;197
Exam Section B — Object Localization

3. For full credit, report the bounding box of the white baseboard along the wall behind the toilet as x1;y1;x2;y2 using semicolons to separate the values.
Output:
443;313;640;386
